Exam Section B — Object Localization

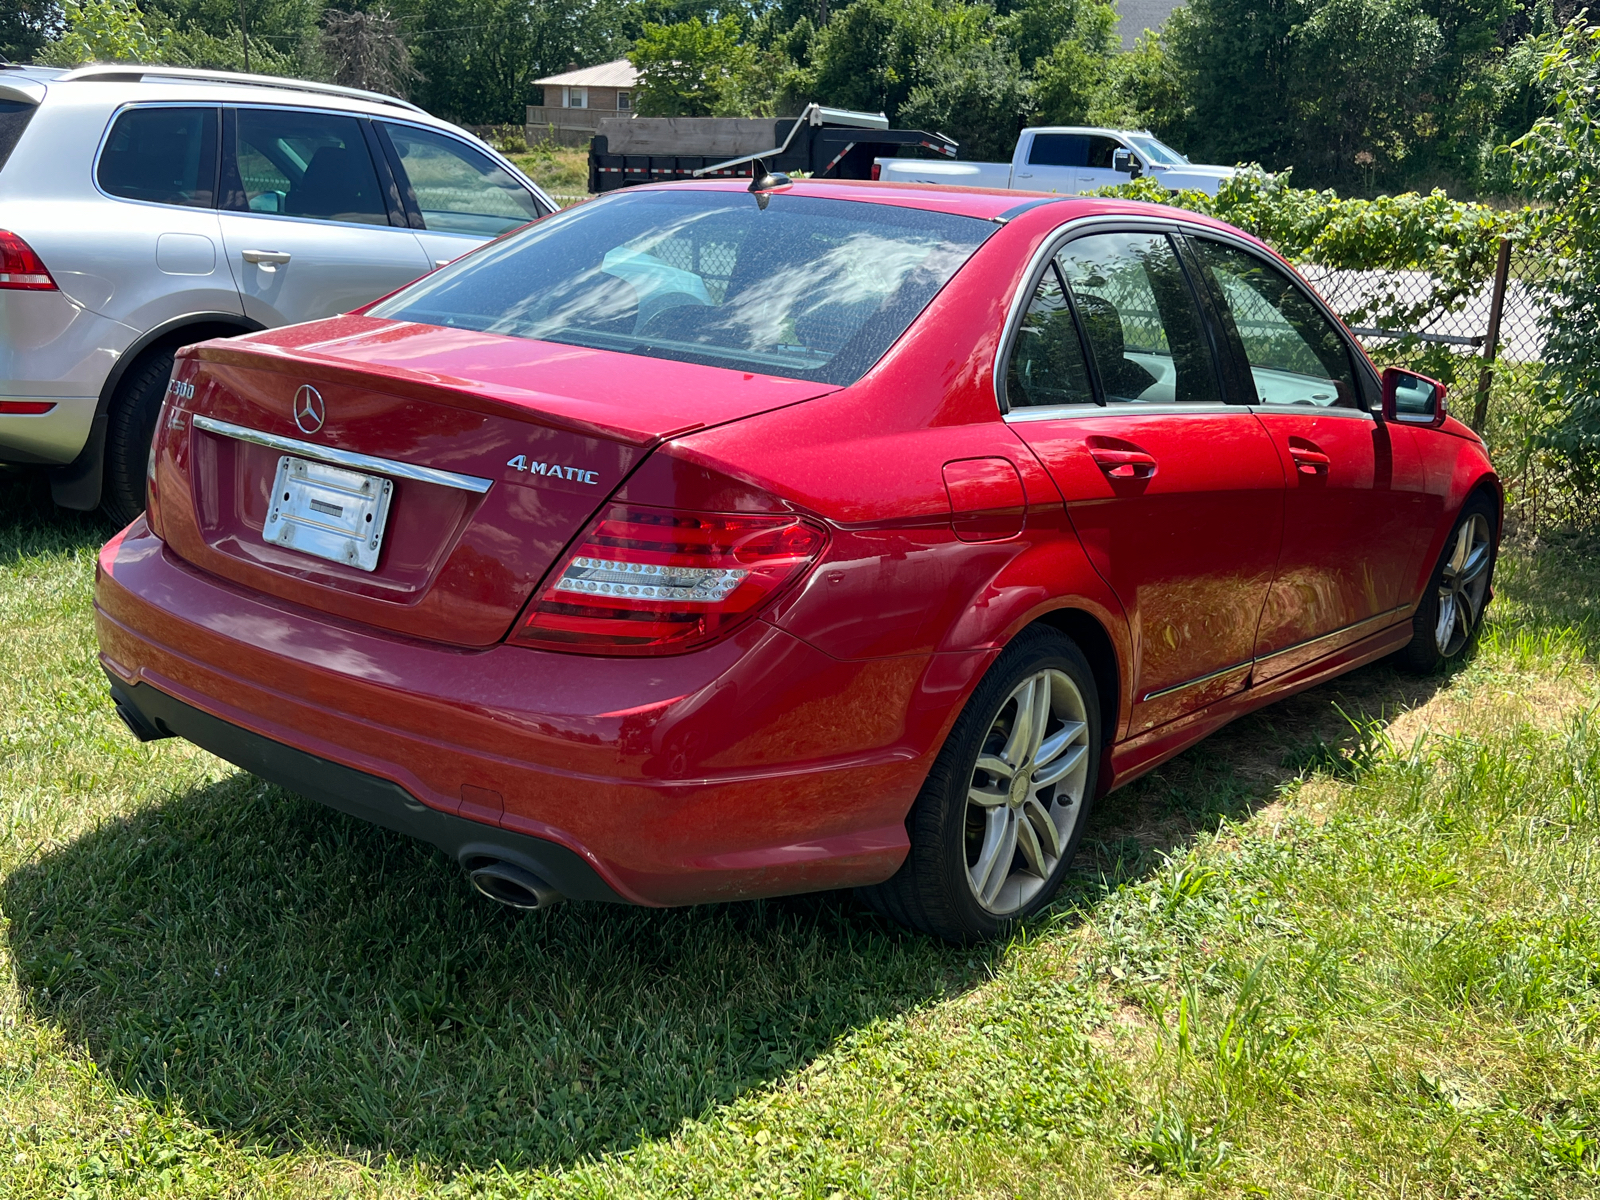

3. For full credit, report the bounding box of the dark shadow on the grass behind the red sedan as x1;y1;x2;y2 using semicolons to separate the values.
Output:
0;773;1000;1170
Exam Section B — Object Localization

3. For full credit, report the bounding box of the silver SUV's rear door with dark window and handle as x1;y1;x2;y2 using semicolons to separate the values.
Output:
221;107;434;326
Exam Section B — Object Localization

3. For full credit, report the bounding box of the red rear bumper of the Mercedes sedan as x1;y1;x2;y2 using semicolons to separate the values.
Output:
96;520;990;904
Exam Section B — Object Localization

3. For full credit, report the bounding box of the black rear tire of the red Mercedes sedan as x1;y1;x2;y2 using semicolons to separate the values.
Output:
859;626;1101;946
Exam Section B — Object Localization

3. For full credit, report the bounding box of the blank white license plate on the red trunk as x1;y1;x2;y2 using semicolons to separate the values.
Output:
261;454;395;571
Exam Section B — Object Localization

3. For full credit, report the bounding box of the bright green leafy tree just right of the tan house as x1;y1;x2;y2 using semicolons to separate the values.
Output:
629;16;754;117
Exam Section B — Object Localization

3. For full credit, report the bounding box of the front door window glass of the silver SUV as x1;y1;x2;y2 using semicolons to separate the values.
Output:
384;125;542;237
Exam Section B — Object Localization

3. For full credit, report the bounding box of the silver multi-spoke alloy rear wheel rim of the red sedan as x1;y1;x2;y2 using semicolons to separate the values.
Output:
966;667;1090;917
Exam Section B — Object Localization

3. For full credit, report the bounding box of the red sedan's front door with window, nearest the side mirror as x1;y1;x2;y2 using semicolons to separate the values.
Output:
1192;238;1427;682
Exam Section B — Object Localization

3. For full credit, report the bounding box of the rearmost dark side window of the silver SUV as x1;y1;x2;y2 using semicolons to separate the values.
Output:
96;107;218;208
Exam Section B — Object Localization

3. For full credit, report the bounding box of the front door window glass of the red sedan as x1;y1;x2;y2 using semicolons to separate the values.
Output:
1194;238;1357;408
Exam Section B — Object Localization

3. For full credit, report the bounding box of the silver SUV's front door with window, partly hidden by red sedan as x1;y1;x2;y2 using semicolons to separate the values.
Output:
374;122;547;266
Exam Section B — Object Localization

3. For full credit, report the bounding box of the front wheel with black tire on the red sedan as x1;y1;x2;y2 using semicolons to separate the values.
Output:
1395;494;1499;675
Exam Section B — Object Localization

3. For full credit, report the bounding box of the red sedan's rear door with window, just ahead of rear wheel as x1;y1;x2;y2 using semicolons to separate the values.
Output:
1005;232;1283;733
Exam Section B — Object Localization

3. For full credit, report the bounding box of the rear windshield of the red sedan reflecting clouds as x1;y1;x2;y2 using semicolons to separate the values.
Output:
370;189;995;384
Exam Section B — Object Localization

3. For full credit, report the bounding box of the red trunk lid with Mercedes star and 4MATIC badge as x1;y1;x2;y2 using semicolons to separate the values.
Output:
152;317;834;646
